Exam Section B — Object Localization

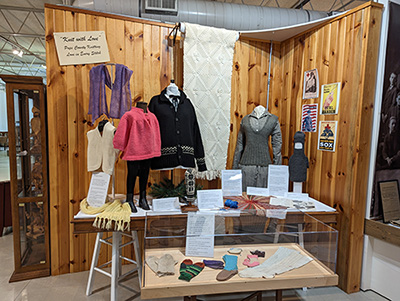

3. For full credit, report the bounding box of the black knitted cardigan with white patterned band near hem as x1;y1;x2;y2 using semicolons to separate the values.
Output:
148;89;207;171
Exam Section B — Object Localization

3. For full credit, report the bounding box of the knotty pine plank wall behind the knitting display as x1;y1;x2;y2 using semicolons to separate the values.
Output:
45;3;381;292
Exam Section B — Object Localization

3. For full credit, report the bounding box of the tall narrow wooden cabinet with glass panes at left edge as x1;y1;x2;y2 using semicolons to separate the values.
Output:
0;75;50;282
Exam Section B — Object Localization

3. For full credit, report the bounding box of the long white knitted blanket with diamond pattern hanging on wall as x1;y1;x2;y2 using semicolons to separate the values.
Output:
183;23;238;180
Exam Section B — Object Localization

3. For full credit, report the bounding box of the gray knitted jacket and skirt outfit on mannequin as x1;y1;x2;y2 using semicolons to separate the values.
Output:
232;111;282;191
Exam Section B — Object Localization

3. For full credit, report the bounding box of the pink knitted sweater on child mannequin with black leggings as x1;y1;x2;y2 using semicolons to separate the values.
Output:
113;107;161;161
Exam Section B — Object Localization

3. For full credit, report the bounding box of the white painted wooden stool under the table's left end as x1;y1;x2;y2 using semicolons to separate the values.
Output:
86;231;142;301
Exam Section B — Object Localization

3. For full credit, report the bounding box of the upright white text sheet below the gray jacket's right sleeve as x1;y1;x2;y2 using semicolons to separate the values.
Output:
268;164;289;197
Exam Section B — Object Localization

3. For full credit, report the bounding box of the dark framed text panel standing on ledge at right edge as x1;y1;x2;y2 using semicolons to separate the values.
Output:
378;180;400;223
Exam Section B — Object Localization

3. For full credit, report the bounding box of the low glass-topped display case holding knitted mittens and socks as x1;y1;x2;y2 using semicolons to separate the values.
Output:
141;210;338;299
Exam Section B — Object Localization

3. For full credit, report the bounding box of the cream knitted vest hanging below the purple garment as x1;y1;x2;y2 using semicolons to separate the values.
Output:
86;122;119;175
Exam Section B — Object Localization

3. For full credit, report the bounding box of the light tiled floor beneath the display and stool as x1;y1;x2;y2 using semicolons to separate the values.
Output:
0;234;387;301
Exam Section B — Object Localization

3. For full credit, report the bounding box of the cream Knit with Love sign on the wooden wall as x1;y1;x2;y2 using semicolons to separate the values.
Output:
53;31;110;66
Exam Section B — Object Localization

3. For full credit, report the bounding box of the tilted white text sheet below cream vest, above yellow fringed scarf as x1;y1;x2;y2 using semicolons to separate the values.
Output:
86;172;110;207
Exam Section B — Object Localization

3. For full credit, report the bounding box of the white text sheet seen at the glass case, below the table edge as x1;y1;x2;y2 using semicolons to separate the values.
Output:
185;212;215;258
